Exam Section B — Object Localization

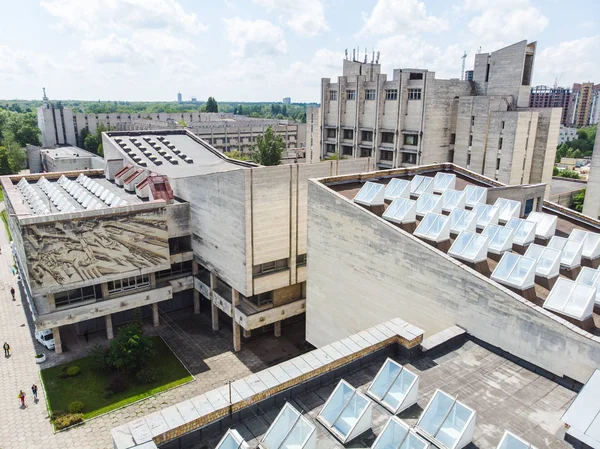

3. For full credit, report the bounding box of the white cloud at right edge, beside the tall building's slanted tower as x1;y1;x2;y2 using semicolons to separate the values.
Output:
533;34;600;87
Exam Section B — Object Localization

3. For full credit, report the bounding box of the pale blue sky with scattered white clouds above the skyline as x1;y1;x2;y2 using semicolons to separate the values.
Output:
0;0;600;102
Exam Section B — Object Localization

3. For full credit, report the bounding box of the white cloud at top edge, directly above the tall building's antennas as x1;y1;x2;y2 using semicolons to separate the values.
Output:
358;0;448;36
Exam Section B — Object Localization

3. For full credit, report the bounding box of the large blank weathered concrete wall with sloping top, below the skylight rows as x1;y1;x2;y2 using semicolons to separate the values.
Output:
306;181;600;382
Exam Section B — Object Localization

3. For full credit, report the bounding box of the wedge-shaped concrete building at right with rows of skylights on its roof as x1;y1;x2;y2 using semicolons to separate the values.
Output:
306;164;600;382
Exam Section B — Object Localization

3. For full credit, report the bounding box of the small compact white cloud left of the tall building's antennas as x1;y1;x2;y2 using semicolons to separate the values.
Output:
223;17;287;57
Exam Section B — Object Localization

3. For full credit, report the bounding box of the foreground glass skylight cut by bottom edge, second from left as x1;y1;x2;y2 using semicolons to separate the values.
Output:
259;402;317;449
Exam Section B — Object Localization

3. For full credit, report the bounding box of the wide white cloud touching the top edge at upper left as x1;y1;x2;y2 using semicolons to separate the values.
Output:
41;0;207;34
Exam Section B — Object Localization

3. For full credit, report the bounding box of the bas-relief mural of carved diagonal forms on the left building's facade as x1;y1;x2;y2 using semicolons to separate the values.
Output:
23;211;170;287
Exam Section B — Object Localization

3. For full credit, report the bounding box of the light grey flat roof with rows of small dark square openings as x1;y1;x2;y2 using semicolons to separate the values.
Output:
105;130;256;178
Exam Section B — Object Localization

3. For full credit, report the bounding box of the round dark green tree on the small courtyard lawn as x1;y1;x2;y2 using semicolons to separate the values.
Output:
106;323;152;372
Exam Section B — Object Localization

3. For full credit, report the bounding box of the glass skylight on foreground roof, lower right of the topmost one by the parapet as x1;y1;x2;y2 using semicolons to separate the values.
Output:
416;390;476;449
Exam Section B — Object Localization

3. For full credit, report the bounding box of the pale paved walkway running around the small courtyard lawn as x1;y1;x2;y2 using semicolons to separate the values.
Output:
0;207;308;449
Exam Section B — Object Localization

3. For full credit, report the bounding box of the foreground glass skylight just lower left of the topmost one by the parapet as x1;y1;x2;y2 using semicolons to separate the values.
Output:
317;380;373;443
